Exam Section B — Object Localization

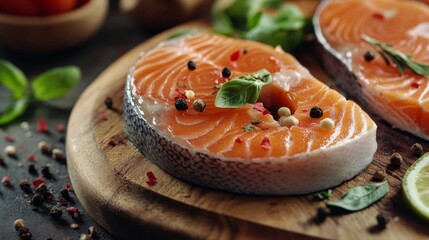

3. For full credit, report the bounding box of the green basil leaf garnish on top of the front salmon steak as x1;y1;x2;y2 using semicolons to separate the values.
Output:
215;69;272;108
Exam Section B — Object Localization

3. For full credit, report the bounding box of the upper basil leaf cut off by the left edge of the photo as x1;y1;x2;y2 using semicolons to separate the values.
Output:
0;59;28;99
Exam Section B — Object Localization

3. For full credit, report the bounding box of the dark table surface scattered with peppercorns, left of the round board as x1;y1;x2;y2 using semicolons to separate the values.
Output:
0;0;153;240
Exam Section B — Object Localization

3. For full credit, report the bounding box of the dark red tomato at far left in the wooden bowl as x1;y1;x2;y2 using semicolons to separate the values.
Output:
0;0;39;16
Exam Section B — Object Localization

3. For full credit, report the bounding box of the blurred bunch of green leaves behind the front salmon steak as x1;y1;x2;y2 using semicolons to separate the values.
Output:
212;0;311;51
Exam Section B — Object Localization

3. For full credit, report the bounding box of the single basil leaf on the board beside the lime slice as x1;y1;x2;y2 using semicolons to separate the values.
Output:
326;181;389;211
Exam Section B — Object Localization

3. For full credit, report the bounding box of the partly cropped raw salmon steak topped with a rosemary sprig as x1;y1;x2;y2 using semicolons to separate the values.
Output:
314;0;429;140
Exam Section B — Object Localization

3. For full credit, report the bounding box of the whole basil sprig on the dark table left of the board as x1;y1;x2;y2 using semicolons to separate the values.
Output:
0;59;81;125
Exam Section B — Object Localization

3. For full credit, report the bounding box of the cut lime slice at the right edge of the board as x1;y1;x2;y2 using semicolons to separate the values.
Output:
402;152;429;221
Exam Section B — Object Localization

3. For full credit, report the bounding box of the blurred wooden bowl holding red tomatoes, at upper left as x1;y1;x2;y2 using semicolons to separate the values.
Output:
0;0;109;53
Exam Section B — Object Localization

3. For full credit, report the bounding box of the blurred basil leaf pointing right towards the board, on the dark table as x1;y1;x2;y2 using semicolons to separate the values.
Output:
31;66;81;101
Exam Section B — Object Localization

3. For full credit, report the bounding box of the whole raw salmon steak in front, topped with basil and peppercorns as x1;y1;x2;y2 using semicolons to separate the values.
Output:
124;33;377;195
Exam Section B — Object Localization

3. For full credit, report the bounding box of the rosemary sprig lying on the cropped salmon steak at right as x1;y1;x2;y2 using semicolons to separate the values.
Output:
362;35;429;77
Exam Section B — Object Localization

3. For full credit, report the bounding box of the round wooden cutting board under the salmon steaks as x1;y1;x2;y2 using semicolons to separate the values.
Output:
66;23;429;239
